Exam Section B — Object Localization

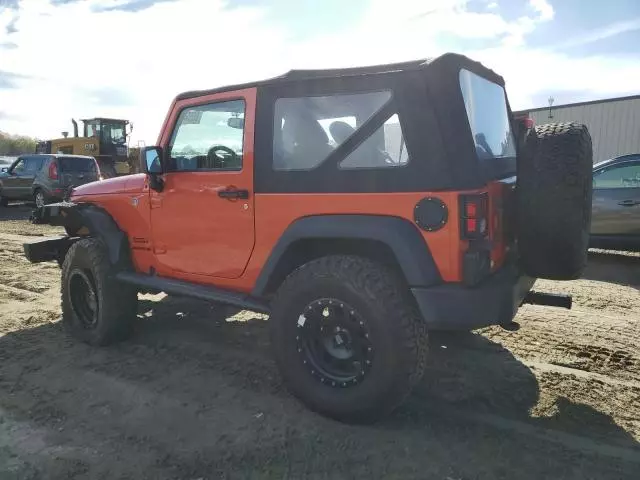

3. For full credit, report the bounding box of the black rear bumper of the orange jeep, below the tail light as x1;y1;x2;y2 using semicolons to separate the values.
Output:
411;266;536;330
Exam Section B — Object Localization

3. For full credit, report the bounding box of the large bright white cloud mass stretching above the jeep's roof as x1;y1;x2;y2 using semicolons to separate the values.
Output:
0;0;640;143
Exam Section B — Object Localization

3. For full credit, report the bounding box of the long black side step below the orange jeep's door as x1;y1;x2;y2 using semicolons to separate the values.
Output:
116;272;269;313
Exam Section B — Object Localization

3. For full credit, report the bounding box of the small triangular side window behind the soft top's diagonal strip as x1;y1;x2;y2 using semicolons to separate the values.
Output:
338;114;409;169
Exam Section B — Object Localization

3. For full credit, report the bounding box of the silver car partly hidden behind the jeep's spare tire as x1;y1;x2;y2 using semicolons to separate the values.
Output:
591;154;640;251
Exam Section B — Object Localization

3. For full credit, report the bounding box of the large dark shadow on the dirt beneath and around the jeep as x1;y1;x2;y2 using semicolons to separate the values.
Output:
0;298;640;479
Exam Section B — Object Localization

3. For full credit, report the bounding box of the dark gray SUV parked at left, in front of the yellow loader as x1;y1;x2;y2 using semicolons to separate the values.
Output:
0;154;101;206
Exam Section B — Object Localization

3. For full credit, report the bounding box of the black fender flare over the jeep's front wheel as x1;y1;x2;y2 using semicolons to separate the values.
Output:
31;202;129;267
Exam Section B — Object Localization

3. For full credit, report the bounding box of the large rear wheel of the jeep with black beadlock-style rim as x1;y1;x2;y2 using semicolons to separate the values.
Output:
269;256;427;423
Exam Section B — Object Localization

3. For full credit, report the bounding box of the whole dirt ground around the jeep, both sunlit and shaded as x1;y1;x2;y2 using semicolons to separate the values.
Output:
0;206;640;480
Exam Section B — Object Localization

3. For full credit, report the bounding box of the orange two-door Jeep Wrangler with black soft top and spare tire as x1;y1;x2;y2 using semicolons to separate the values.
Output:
24;54;592;422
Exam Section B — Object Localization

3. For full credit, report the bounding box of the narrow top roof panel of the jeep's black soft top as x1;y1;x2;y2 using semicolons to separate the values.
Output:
176;53;504;100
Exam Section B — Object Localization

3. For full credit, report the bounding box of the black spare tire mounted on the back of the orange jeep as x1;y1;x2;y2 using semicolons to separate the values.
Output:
516;123;593;280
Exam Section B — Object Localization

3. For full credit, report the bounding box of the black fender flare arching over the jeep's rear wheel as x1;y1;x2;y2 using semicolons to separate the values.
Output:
252;215;442;297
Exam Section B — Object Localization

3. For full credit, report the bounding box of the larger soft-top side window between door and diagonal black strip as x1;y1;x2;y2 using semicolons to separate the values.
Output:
273;91;391;170
